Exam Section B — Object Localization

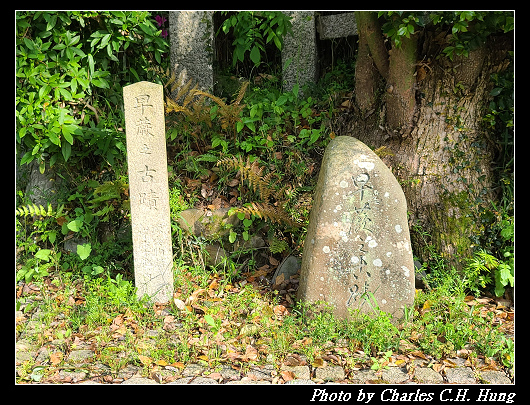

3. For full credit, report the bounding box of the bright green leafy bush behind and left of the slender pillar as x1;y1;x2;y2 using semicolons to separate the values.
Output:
16;11;169;172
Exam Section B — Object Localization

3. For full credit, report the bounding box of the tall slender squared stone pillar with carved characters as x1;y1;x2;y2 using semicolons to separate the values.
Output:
123;82;173;302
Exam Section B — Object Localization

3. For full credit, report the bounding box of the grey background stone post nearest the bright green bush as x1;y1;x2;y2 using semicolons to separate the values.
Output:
169;10;214;92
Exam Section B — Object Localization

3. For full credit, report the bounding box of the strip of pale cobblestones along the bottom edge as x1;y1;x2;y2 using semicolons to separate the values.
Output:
16;339;512;384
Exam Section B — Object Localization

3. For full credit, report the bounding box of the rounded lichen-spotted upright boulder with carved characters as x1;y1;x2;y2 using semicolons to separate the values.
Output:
298;136;414;319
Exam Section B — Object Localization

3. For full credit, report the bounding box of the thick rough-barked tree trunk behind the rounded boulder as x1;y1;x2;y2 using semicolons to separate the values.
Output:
336;33;509;267
